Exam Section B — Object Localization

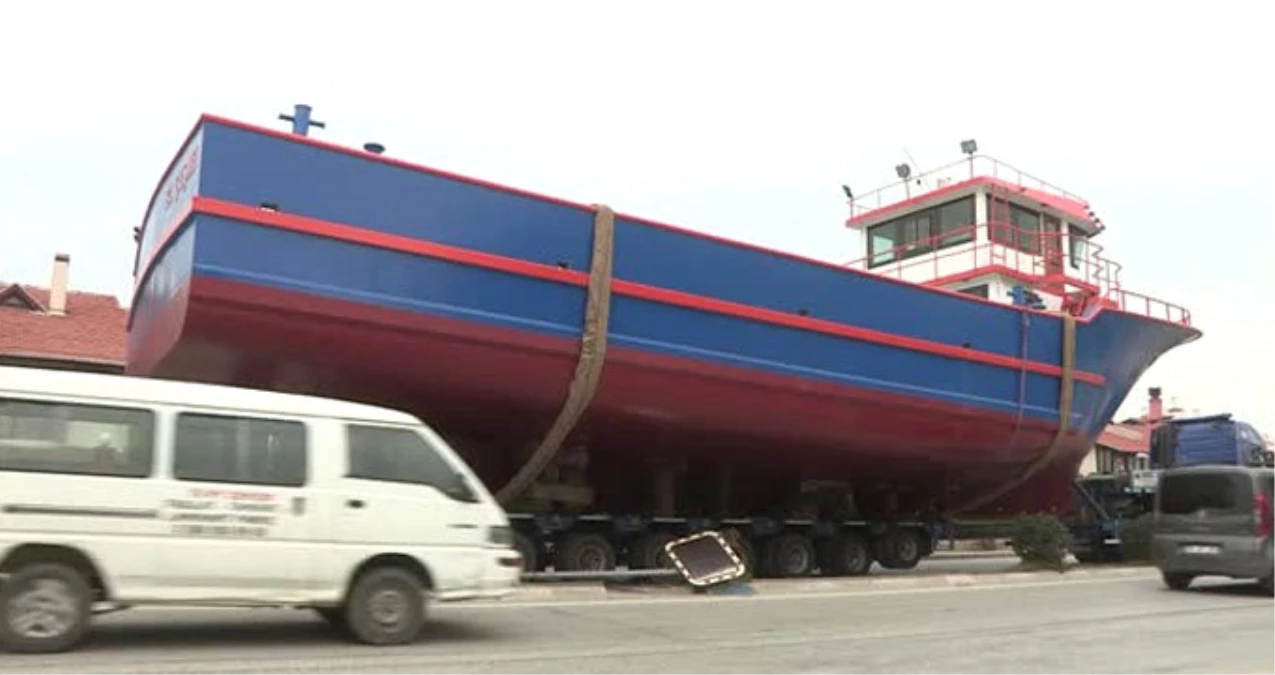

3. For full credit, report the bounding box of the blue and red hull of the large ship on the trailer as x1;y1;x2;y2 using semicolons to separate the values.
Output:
129;117;1199;512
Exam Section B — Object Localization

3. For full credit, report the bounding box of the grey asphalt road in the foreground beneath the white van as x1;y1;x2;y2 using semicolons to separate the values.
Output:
0;572;1275;675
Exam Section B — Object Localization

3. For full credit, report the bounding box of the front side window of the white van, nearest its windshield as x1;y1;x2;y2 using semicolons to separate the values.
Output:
346;425;474;501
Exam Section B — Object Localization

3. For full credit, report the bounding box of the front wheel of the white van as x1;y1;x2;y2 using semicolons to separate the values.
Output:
346;567;425;644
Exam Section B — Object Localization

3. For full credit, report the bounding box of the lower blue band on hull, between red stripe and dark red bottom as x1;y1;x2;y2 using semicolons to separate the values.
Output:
186;216;1105;424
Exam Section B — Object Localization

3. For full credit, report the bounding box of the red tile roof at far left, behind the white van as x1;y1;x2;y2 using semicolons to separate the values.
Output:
0;283;129;365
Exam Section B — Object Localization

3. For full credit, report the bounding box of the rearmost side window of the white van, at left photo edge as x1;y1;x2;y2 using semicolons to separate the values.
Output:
0;398;154;478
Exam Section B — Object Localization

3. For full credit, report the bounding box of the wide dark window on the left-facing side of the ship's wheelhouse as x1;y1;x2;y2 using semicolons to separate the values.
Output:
867;197;974;267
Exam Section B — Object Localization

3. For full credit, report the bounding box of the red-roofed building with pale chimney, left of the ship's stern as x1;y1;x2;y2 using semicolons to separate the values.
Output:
0;254;129;373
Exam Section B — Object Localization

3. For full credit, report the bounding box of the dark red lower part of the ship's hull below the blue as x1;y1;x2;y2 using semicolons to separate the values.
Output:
130;273;1084;508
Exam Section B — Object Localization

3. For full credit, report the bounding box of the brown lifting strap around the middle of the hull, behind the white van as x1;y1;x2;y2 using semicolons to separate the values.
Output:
496;204;616;505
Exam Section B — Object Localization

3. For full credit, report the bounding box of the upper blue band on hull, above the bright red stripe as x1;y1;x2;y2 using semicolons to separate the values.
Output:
186;124;1076;370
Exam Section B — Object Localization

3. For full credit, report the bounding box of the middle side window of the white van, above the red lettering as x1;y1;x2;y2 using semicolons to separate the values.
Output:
172;412;307;487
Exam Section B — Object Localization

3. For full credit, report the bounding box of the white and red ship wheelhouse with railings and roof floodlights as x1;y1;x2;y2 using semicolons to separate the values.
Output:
845;151;1191;325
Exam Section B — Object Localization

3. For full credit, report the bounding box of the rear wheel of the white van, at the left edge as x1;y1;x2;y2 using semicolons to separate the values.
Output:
0;564;93;653
